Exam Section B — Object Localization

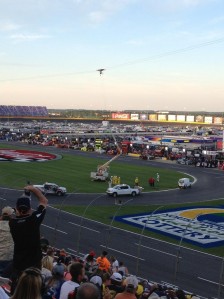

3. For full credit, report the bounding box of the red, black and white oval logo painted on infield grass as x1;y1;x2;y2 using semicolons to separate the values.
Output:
0;149;59;162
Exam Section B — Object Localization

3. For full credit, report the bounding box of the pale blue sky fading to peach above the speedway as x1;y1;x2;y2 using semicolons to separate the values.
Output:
0;0;224;112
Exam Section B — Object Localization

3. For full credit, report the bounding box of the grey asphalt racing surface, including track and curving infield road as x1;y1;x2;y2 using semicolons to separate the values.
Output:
0;144;224;299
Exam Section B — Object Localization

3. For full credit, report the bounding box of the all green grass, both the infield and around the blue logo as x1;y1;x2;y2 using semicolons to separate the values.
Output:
0;144;224;256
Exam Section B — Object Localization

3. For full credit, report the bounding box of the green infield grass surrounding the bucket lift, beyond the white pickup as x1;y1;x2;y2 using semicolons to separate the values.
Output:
0;145;189;193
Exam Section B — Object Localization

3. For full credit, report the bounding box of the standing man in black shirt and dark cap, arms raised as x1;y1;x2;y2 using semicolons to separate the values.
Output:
9;185;48;291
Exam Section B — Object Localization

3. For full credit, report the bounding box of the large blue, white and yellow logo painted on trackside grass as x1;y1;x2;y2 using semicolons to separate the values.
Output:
116;206;224;247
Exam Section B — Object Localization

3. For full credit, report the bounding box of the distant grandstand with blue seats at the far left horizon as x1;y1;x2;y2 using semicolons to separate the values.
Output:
0;105;48;117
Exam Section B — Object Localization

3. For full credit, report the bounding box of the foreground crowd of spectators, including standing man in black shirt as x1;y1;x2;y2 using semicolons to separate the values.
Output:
0;185;199;299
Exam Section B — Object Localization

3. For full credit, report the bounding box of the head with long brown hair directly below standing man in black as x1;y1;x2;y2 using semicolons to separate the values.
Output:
11;267;43;299
